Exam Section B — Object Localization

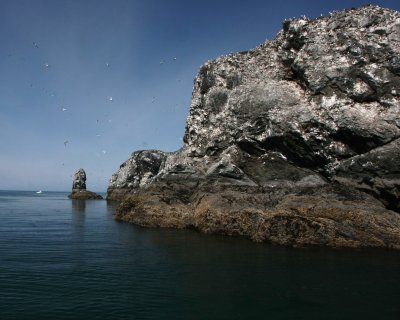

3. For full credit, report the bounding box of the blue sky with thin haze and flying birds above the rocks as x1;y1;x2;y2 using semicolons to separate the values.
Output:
0;0;400;192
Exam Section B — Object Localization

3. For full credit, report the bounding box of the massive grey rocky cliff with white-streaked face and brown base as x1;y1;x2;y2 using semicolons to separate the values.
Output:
107;6;400;249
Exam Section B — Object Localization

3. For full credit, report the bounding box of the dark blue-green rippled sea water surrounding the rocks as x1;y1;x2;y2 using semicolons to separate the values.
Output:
0;191;400;320
